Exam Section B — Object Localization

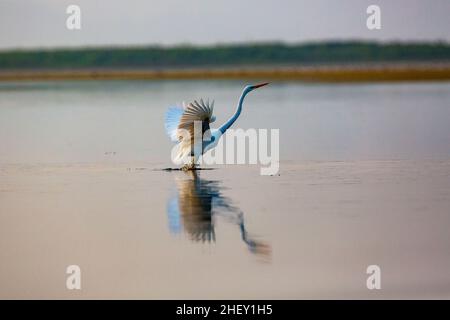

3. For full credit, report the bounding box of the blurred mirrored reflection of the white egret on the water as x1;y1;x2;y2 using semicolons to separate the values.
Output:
167;171;271;257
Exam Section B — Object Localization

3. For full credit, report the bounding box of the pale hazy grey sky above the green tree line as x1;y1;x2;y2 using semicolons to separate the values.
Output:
0;0;450;49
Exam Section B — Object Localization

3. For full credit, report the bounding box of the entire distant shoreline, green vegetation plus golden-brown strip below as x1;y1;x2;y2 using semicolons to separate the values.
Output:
0;41;450;82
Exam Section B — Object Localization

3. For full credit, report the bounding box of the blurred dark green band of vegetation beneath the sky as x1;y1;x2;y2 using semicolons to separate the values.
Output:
0;42;450;70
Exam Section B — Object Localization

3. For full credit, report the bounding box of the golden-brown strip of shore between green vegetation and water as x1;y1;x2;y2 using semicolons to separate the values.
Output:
0;63;450;82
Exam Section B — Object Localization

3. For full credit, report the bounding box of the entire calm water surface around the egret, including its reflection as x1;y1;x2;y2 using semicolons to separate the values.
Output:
0;81;450;298
